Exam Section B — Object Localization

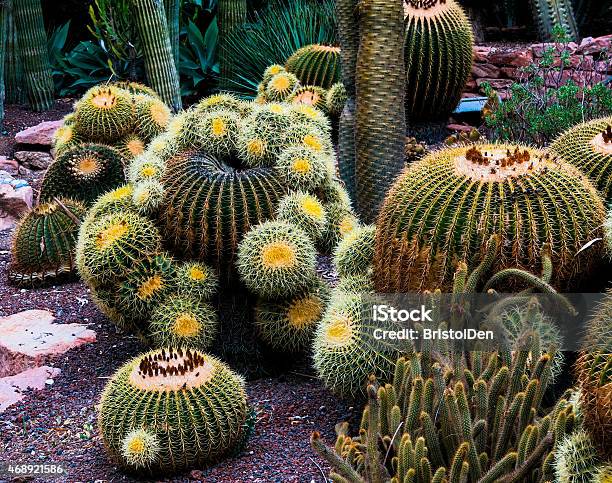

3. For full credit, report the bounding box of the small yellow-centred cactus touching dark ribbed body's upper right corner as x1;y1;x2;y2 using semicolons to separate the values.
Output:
276;146;329;191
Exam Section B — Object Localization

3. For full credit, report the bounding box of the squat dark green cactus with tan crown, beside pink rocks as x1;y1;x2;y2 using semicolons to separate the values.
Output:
39;144;125;205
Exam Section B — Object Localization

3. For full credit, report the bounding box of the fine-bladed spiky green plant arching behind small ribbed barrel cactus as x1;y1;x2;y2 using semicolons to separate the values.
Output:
220;0;336;97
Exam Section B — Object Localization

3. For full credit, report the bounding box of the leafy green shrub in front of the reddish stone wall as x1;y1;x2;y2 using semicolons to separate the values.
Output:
484;28;612;146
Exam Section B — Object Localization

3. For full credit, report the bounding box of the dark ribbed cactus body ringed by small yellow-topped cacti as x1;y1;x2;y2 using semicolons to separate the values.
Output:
160;152;285;276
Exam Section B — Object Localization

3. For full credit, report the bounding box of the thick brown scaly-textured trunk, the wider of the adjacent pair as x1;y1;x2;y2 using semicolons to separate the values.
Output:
355;0;406;223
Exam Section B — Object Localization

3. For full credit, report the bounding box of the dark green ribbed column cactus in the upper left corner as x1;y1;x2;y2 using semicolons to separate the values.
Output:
13;0;55;111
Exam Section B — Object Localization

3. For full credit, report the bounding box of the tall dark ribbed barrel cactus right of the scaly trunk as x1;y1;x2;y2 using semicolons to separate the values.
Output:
404;0;474;122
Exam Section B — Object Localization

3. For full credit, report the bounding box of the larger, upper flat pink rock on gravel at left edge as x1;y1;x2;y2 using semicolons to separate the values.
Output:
0;310;96;376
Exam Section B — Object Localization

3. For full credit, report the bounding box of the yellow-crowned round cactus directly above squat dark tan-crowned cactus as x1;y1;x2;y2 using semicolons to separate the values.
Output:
74;85;135;143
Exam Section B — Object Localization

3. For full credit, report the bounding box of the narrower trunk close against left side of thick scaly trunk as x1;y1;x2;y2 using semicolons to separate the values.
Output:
336;0;359;201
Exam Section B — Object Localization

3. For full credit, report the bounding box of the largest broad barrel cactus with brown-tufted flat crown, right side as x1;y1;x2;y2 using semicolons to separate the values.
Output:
374;144;605;292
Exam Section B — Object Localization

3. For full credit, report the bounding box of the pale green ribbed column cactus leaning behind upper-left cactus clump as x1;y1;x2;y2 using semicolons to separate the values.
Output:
132;0;182;112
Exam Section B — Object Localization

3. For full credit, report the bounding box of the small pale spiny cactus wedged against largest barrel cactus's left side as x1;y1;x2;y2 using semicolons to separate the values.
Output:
334;225;376;277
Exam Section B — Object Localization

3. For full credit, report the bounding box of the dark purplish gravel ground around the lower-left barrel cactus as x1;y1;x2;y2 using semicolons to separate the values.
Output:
0;101;356;482
